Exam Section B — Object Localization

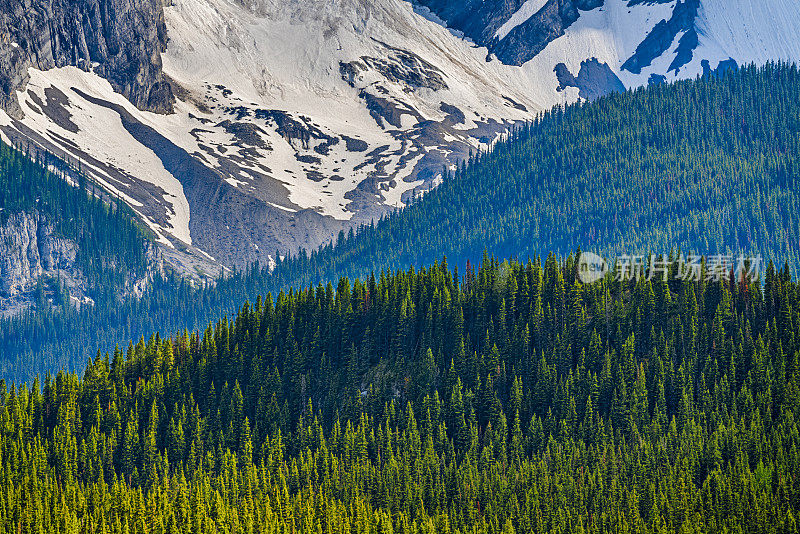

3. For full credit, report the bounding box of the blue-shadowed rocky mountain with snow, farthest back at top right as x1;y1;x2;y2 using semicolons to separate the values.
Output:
412;0;800;75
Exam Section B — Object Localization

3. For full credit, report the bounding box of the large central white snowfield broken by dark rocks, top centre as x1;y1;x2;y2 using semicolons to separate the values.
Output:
158;0;539;219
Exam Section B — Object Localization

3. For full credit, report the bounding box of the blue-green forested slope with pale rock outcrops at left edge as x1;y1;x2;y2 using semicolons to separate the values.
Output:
0;142;158;377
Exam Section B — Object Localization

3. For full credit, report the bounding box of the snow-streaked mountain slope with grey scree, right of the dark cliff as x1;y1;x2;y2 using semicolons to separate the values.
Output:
0;0;539;265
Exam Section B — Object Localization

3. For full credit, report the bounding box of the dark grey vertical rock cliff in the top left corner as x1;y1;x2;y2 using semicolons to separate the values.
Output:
0;0;174;115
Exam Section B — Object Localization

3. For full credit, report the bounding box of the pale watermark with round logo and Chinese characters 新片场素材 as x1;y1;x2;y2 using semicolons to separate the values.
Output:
578;252;764;284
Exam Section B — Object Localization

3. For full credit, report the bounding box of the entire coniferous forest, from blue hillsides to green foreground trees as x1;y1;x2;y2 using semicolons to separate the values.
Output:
0;60;800;534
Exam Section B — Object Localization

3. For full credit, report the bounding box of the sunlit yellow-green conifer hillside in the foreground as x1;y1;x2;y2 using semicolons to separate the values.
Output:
0;256;800;534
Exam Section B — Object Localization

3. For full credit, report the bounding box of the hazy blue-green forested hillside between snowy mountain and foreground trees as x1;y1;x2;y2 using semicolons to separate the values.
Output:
0;65;800;386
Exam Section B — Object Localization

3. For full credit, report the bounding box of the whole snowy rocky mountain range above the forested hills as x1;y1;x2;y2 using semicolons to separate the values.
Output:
0;0;800;268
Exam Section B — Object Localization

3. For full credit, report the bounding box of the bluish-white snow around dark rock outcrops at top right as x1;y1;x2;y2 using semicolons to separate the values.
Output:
522;0;800;101
